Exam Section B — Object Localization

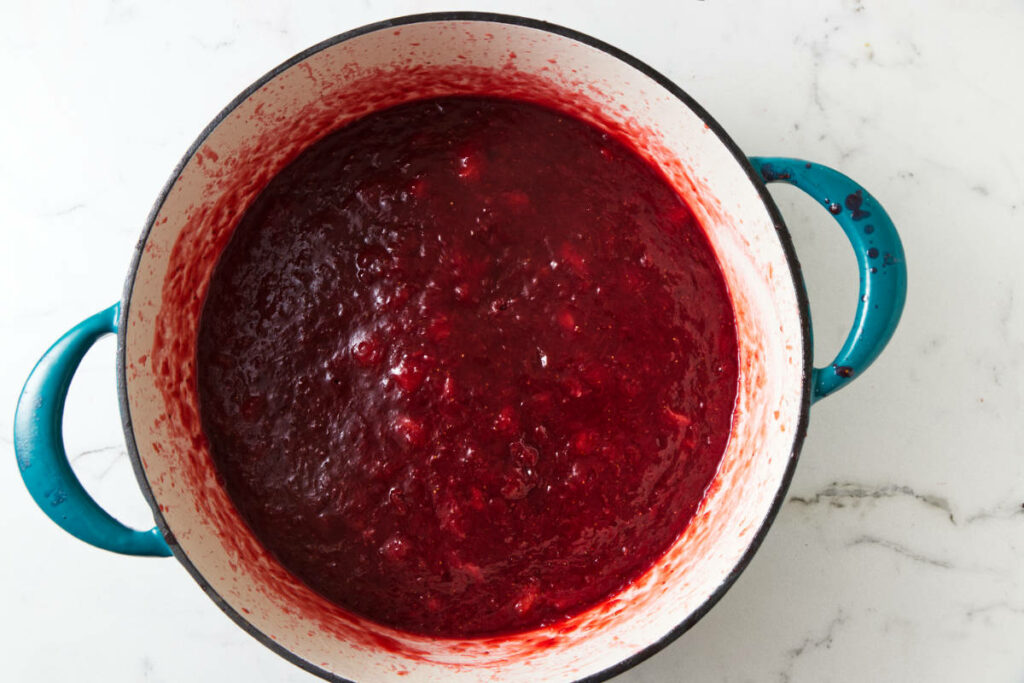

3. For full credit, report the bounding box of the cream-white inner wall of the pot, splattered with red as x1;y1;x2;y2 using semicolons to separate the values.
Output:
124;15;805;681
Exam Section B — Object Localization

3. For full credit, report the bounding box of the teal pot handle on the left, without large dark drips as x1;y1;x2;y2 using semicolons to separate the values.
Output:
14;304;171;557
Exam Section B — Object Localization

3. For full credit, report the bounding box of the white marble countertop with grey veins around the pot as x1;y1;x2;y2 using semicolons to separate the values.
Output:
0;0;1024;683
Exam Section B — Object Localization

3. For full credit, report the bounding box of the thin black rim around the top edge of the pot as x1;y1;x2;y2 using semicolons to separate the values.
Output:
117;11;812;683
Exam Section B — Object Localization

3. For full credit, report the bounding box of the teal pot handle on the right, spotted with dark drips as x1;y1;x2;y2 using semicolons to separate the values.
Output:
751;157;906;400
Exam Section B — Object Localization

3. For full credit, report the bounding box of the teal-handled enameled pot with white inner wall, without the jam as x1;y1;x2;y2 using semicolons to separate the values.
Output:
14;12;906;681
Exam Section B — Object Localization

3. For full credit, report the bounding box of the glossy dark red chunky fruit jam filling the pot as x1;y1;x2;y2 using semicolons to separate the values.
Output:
198;97;737;637
